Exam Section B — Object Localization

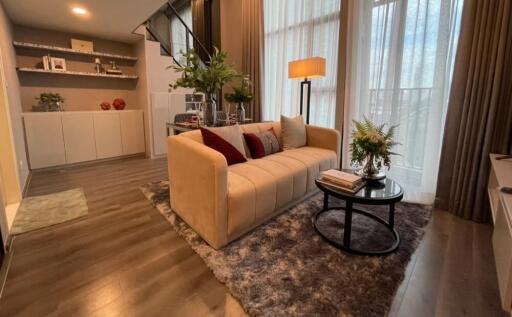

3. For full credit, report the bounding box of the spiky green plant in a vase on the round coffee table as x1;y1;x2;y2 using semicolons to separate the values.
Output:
350;117;398;179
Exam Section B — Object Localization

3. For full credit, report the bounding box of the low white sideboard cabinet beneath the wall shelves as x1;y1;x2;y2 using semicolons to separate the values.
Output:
23;110;146;169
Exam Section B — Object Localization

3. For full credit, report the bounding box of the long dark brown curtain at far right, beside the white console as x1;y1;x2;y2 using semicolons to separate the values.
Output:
436;0;512;222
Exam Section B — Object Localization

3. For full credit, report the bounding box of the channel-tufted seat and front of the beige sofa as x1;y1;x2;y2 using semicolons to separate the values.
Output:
227;147;337;235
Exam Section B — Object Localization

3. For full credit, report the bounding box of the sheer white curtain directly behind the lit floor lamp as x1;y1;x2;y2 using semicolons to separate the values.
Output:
263;0;340;127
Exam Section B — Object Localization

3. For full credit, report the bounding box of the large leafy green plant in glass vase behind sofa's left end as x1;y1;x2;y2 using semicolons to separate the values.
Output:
170;47;241;126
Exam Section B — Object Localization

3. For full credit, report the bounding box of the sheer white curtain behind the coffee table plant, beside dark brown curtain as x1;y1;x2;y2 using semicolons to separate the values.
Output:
343;0;463;203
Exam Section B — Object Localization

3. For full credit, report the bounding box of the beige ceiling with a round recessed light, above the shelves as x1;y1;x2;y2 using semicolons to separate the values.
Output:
0;0;166;42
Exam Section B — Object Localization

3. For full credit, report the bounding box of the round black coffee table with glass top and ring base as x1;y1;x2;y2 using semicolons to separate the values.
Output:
312;174;404;255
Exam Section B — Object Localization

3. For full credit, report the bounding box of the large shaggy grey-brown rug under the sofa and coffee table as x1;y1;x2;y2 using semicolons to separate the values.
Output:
141;181;431;316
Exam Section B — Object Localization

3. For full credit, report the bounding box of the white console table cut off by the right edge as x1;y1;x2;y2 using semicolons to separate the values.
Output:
487;154;512;316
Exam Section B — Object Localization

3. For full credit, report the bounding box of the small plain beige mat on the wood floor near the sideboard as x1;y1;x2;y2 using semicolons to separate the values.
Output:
12;188;89;234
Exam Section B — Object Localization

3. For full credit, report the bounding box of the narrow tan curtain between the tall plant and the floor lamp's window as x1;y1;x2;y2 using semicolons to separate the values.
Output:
242;0;264;122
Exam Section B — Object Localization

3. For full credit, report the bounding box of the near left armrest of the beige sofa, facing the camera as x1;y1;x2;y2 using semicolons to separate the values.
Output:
167;136;228;249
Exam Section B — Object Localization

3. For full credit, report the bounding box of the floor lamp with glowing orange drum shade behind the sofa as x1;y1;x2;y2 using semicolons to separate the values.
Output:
288;57;325;124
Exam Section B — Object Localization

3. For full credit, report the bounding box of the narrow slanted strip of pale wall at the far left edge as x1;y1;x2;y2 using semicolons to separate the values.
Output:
0;3;29;192
